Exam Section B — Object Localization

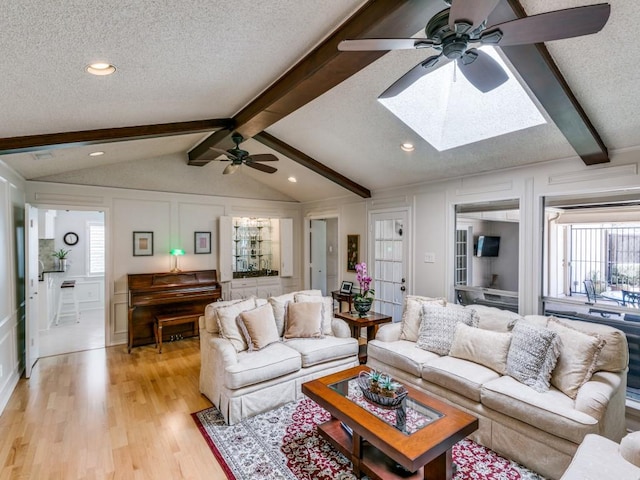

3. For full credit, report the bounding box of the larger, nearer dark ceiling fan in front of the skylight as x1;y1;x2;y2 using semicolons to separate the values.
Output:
338;0;611;98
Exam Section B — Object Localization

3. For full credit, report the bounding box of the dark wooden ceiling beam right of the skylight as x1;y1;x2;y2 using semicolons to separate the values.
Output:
490;0;610;165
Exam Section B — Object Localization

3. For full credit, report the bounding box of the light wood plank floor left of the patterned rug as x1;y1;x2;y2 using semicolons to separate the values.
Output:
0;339;226;480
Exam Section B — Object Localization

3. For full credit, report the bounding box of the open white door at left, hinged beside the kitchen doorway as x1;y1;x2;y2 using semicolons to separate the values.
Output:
25;205;40;378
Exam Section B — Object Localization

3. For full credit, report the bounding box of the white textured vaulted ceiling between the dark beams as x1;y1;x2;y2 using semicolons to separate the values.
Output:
0;0;640;201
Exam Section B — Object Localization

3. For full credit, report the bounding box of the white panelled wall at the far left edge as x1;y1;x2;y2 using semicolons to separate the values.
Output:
0;161;25;413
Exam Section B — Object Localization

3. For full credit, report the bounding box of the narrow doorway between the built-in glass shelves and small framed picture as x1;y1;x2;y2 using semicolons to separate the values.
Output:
308;217;339;295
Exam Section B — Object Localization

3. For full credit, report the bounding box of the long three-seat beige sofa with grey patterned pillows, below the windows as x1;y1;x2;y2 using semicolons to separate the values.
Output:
367;302;628;479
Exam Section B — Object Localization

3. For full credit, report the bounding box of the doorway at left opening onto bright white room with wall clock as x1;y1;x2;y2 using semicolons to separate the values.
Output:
37;208;106;357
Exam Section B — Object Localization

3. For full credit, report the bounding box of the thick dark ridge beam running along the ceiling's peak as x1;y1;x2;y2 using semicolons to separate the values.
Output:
189;0;432;165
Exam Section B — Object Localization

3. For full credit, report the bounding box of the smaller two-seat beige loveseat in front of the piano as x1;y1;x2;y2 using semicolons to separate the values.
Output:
200;291;359;425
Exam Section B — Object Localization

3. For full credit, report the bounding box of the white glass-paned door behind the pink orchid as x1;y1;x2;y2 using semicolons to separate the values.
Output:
369;211;409;322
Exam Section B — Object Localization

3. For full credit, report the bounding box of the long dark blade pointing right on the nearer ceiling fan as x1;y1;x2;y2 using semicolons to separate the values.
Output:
480;3;611;47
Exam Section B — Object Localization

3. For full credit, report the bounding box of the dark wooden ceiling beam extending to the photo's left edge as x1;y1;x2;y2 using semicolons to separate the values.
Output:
0;118;233;155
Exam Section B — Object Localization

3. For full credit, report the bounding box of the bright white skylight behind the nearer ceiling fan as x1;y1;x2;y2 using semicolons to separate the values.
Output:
379;47;546;151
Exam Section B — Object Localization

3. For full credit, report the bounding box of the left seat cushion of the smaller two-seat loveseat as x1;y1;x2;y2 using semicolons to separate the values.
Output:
224;342;302;390
